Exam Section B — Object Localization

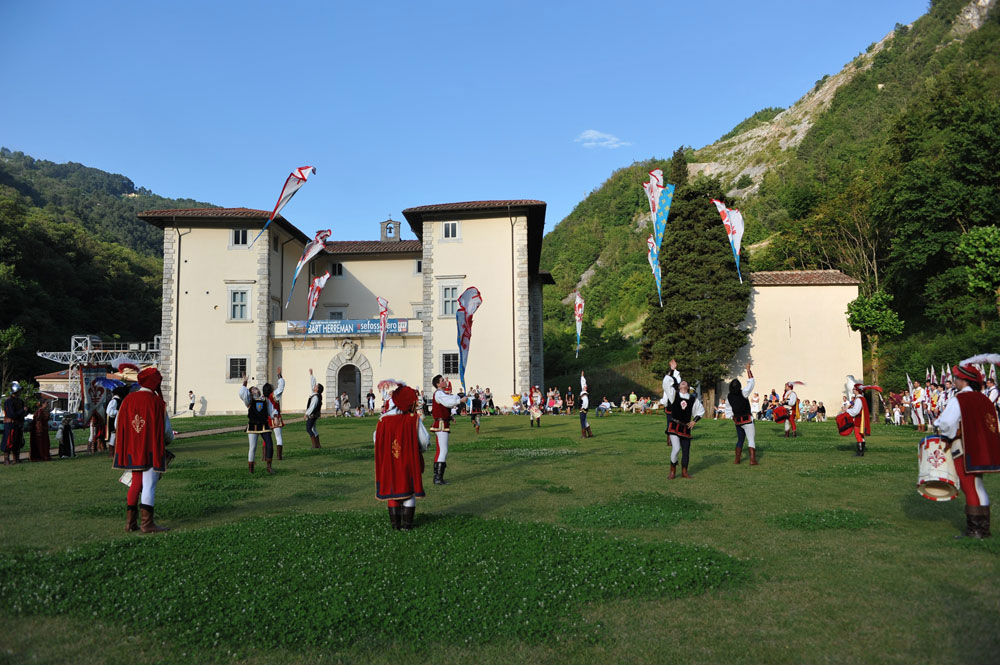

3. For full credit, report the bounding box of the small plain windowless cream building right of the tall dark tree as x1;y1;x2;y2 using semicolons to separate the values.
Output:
732;270;863;419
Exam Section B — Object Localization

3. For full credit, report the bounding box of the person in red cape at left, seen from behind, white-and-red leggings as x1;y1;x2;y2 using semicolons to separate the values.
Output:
114;367;174;533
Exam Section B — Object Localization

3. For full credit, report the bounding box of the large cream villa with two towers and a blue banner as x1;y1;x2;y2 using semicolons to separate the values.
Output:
139;200;552;415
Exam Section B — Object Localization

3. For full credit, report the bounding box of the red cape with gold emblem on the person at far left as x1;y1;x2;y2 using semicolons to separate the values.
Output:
114;390;167;472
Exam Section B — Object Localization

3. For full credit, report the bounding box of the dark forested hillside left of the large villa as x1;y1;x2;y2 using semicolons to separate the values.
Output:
0;149;215;380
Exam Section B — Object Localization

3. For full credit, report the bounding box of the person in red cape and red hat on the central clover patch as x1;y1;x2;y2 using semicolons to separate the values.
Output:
375;386;430;531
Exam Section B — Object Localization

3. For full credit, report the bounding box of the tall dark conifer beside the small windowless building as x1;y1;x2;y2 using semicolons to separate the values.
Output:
641;176;750;402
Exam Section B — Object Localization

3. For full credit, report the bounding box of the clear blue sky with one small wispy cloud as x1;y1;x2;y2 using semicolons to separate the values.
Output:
0;0;927;240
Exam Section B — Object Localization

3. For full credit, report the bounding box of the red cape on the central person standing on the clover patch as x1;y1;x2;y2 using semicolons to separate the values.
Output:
375;413;424;501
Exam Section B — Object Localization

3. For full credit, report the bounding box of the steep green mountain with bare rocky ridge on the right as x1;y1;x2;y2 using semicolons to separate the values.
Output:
541;0;1000;390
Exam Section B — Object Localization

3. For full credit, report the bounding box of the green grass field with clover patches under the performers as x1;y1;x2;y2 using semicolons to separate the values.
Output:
0;415;1000;664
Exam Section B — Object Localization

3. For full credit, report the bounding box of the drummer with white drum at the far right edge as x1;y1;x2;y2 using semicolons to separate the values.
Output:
934;364;1000;538
